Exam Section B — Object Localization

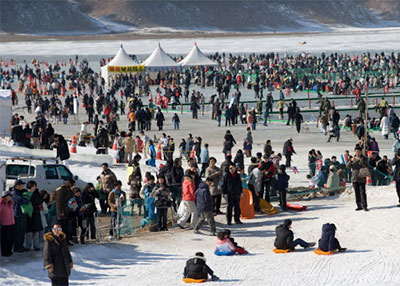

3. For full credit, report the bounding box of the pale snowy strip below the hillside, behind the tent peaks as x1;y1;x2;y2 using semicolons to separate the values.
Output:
0;28;400;57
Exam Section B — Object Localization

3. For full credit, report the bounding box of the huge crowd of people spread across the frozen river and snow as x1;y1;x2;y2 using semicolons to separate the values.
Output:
0;53;400;283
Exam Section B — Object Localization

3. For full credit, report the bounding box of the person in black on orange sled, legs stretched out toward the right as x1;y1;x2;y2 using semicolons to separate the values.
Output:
274;219;315;251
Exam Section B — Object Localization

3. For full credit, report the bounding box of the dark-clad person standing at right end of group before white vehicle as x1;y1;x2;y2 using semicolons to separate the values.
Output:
81;183;99;239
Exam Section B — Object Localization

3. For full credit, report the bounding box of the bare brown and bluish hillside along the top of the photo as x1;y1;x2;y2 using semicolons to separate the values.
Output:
0;0;400;34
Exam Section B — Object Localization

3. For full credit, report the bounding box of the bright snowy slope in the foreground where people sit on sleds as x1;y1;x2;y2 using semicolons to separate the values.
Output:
0;186;400;286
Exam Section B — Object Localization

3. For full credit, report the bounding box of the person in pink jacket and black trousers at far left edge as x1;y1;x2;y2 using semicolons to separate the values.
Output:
0;191;15;256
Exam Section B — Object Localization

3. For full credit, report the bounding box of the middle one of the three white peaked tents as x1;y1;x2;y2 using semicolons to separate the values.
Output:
142;44;181;72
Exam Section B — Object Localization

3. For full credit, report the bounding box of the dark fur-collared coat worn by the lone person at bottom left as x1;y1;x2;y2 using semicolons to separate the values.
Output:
43;232;72;279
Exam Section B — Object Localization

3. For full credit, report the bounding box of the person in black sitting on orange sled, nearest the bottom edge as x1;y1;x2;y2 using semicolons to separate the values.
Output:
183;252;219;281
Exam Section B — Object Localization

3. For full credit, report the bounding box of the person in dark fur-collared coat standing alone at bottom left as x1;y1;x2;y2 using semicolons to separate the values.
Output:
43;224;74;286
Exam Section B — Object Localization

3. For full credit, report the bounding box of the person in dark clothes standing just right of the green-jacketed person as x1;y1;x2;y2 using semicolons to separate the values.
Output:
25;181;43;250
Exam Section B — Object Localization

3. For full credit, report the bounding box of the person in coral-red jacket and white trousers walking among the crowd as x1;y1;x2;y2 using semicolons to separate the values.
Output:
178;171;198;229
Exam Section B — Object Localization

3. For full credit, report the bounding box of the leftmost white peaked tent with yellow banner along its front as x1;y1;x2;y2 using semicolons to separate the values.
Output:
101;45;145;85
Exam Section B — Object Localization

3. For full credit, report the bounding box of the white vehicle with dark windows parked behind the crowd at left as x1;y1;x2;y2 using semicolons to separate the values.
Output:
0;158;87;196
